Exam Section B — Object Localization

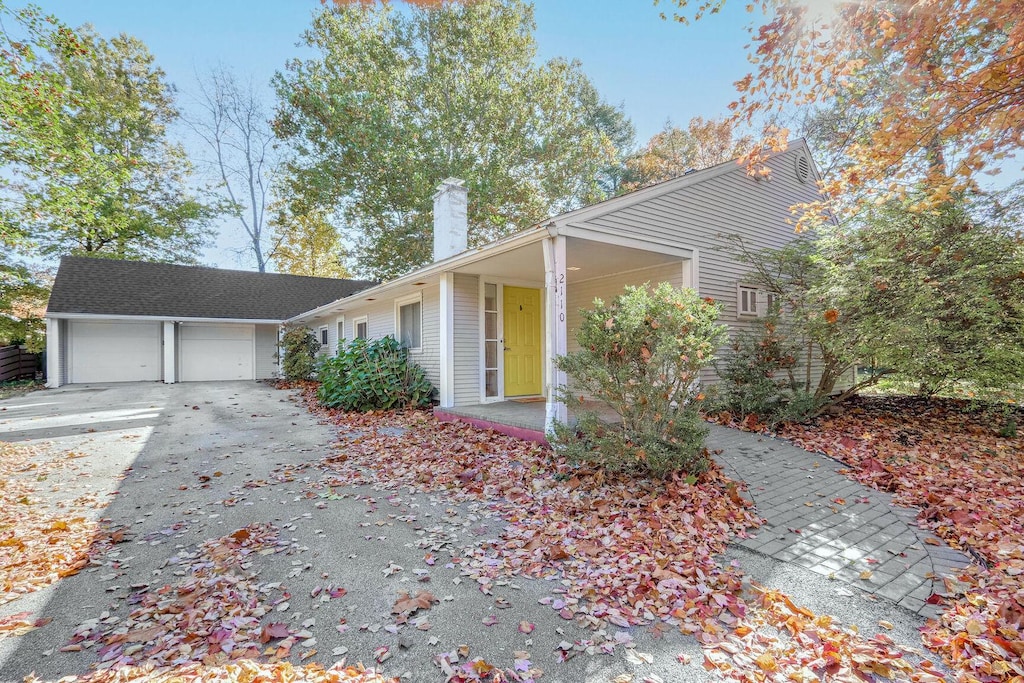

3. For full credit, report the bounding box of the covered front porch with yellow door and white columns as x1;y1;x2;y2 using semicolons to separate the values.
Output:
436;227;697;423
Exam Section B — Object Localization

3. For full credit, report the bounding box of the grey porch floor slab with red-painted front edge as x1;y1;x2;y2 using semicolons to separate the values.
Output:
434;398;618;444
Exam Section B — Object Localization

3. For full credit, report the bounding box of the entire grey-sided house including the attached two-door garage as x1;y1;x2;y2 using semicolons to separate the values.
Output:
47;140;835;438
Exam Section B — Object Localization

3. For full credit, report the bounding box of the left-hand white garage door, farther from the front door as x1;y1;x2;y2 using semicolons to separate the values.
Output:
68;321;161;384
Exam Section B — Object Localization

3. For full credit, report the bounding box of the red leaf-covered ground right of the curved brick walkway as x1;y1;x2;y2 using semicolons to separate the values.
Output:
780;396;1024;683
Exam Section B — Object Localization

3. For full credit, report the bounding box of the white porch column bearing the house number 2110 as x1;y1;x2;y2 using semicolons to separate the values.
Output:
544;233;568;434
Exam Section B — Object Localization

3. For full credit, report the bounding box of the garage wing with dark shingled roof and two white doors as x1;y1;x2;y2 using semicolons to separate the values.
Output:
46;256;375;387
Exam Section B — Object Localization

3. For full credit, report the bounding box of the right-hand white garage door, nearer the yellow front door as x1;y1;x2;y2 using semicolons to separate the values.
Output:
178;323;256;382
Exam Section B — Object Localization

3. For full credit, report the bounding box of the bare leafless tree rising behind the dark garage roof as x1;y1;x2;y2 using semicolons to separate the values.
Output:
188;68;275;272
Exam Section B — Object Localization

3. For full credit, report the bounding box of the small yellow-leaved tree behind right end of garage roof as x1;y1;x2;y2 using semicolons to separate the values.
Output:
270;209;350;278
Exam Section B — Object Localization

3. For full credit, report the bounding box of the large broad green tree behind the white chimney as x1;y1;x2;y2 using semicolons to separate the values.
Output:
275;0;614;278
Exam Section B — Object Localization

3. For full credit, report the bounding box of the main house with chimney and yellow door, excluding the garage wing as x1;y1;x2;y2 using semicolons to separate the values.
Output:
287;140;835;431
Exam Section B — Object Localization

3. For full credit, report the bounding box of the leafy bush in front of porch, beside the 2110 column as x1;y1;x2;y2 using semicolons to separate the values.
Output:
553;283;725;477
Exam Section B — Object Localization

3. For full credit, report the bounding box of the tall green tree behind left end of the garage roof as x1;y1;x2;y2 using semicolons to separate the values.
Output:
3;27;213;262
